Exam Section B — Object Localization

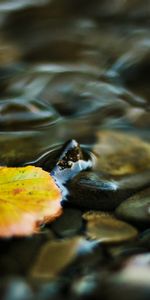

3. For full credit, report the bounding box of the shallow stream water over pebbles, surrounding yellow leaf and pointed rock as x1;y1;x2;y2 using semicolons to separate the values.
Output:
0;0;150;300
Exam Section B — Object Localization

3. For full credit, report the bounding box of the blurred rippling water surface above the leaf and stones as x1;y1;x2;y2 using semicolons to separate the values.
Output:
0;0;150;165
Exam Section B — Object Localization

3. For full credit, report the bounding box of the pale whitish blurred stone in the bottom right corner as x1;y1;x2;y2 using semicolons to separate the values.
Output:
104;253;150;300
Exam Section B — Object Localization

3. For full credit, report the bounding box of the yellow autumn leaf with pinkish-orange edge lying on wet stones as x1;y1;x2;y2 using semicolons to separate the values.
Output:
0;166;62;237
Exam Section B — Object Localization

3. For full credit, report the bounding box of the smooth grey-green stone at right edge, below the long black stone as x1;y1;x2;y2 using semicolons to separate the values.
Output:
115;188;150;223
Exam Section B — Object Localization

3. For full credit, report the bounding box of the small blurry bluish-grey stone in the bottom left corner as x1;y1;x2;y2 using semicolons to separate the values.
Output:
0;277;33;300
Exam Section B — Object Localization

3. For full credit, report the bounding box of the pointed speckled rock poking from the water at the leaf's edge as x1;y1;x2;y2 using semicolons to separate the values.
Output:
28;140;92;176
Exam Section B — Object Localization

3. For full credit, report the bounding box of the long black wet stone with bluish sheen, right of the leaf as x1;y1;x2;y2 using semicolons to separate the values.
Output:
68;171;150;211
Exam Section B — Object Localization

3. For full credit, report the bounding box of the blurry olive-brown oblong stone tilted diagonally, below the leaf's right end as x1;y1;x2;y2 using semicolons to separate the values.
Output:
30;237;85;282
